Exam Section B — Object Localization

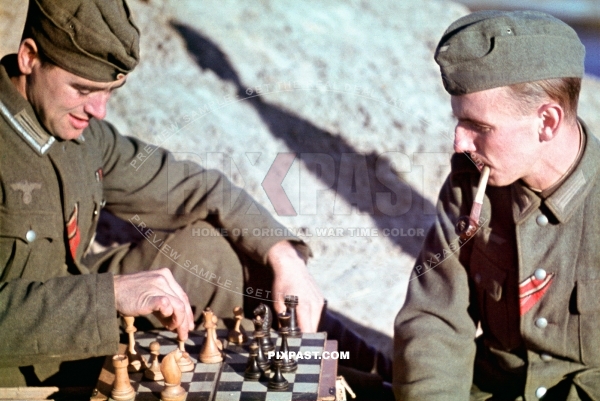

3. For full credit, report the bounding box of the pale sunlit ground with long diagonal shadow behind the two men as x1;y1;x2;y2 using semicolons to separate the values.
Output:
0;0;600;353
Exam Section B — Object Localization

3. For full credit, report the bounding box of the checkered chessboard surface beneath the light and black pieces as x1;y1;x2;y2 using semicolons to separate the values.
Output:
92;330;337;401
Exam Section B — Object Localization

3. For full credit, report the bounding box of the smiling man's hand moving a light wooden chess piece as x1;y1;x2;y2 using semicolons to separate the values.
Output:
114;268;194;340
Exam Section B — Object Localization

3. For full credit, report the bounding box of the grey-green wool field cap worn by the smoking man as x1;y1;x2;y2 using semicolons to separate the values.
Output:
435;11;585;95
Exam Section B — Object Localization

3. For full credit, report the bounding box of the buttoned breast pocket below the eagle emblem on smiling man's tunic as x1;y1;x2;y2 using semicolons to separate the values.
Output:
0;210;65;281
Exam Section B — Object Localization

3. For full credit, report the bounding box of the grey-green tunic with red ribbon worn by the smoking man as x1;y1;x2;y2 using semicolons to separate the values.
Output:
393;123;600;401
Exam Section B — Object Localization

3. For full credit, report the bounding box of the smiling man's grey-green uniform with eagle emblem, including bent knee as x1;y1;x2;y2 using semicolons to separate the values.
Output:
0;58;302;385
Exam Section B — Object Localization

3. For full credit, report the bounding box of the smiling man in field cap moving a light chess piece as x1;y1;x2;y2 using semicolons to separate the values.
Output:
0;0;390;386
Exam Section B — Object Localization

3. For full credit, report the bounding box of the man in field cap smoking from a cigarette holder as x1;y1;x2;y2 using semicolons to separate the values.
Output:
393;11;600;401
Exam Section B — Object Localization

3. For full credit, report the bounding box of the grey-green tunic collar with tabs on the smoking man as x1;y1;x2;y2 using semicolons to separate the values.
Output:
512;120;600;224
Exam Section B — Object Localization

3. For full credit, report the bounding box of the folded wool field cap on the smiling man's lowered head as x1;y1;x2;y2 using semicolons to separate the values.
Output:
25;0;140;82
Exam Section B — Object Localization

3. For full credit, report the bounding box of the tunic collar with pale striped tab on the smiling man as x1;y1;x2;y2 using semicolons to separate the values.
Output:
0;54;85;156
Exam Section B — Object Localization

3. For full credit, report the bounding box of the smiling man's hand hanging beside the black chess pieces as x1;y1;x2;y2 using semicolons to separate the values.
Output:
267;241;324;333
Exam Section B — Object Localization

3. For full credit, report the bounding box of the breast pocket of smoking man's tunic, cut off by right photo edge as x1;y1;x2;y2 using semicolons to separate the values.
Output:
577;280;600;366
